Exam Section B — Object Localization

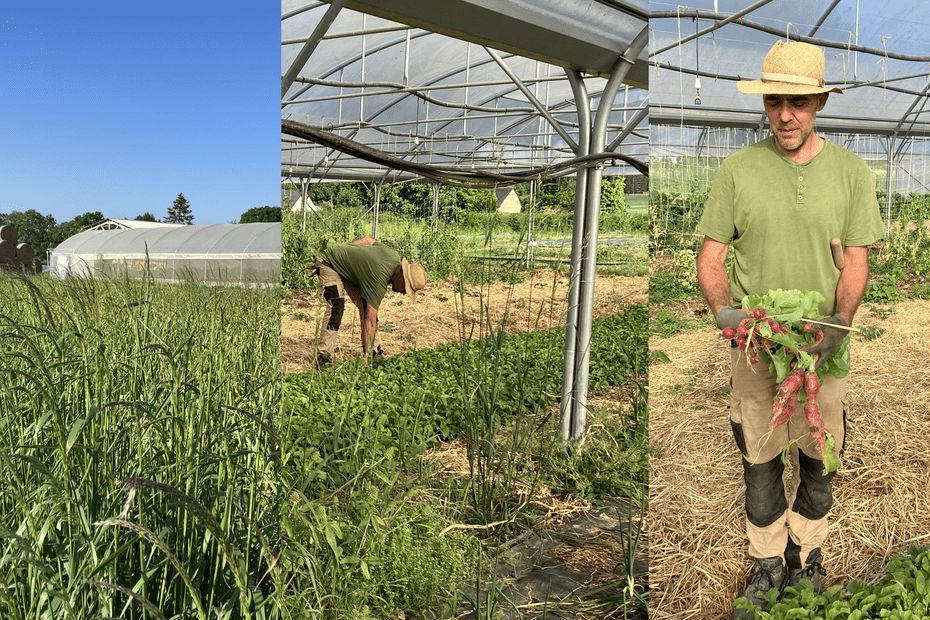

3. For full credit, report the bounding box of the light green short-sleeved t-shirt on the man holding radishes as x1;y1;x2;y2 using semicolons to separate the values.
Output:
698;136;884;315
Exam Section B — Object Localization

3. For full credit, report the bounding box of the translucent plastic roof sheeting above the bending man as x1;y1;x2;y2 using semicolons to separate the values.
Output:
281;0;648;180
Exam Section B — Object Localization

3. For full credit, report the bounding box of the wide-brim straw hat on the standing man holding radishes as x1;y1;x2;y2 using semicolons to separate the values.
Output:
736;41;843;95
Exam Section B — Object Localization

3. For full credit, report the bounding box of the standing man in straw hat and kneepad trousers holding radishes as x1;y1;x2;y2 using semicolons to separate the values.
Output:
697;41;883;618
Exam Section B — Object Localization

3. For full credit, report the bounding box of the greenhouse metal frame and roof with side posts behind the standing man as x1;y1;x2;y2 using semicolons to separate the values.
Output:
649;0;930;226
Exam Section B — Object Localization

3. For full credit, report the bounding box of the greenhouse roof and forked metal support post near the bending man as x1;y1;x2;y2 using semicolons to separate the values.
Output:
281;0;649;438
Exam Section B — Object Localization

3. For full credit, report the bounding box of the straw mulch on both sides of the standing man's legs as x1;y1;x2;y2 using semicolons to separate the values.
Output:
647;300;930;619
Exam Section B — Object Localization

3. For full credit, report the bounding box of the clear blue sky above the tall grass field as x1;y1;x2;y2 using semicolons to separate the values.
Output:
0;0;281;224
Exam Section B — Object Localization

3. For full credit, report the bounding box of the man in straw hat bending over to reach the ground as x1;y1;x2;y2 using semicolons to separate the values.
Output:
315;237;426;370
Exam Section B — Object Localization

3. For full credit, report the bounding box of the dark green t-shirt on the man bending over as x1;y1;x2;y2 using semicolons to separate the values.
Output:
323;241;400;308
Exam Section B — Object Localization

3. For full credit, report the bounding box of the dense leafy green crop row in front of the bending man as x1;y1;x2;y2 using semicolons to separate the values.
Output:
283;306;648;488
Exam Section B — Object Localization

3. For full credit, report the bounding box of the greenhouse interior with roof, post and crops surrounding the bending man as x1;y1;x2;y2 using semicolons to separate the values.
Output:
281;0;649;619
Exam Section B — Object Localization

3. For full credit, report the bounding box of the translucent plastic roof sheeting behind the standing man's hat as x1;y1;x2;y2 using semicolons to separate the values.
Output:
649;0;930;136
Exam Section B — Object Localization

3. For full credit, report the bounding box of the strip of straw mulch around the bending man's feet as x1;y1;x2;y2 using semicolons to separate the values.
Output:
281;269;649;372
